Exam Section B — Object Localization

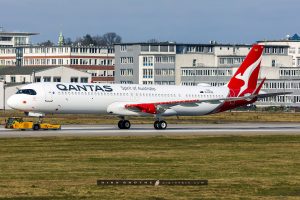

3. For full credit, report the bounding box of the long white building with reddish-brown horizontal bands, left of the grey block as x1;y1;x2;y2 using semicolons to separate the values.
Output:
0;46;115;83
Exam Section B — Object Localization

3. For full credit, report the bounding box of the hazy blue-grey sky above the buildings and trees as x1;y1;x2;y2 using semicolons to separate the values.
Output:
0;0;300;43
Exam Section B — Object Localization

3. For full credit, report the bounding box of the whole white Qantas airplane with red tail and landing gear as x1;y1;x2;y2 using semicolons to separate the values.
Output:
7;44;290;129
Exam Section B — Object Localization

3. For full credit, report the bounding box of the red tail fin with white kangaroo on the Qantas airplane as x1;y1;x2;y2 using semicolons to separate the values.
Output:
227;44;264;97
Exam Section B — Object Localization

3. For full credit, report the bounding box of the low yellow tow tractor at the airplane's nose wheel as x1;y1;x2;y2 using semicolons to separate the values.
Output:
5;117;61;131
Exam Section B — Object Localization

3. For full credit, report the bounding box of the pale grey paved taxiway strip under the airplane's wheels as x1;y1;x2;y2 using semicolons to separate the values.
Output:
0;123;300;137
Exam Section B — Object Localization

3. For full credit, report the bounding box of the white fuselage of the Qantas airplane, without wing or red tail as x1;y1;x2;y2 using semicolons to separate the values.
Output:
8;83;229;116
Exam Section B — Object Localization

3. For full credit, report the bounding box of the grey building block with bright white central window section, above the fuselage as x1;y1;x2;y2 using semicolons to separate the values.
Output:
115;42;176;85
